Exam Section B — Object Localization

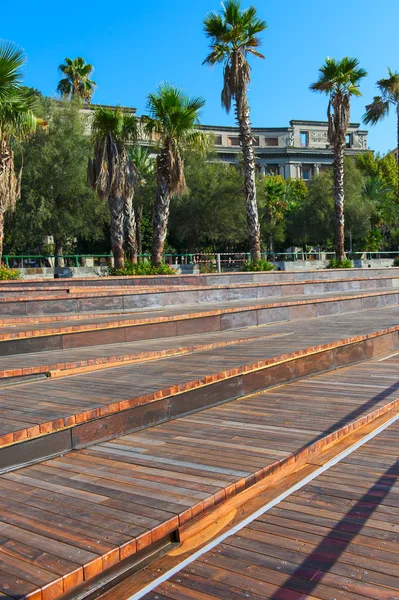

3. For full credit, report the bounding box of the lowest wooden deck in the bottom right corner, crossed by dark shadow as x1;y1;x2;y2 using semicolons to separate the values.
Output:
144;412;399;600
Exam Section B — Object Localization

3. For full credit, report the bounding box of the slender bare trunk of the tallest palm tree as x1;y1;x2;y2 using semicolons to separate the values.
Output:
236;89;261;261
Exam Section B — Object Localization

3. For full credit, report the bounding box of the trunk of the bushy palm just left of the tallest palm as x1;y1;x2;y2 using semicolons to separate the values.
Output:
151;153;170;267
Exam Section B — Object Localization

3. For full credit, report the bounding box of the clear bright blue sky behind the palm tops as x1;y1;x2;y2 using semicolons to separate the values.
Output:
0;0;399;153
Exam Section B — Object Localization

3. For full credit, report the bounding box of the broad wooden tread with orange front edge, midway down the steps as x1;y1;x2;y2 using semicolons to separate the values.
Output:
0;307;399;445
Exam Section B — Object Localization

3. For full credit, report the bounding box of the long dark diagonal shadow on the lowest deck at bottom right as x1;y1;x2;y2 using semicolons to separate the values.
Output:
271;460;399;600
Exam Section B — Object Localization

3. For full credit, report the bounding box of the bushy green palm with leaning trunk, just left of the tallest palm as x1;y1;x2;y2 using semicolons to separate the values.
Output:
144;83;206;266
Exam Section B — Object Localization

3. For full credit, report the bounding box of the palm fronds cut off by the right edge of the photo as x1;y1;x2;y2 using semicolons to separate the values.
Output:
363;67;399;202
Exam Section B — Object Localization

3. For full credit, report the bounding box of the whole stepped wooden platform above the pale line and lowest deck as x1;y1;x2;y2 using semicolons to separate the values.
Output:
0;269;399;600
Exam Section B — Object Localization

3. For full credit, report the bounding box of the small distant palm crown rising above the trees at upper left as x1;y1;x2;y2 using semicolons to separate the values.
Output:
57;56;96;104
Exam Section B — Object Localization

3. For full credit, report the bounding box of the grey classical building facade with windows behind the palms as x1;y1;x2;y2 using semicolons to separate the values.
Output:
201;121;368;181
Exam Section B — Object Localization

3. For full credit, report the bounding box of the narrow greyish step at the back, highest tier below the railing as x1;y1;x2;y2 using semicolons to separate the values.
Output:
0;271;399;317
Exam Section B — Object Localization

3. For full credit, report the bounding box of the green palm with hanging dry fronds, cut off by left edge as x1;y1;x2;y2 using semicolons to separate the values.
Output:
0;43;38;262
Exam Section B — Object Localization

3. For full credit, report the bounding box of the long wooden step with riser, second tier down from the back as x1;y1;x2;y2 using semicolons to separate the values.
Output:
0;289;399;356
